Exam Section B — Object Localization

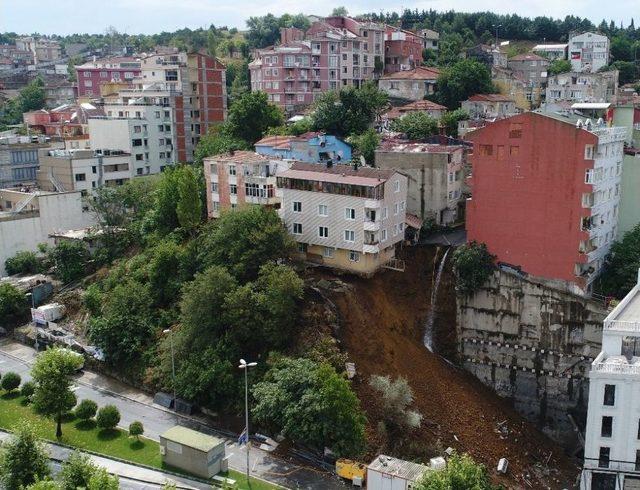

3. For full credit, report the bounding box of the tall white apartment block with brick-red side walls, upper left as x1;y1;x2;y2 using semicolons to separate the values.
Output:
119;52;227;162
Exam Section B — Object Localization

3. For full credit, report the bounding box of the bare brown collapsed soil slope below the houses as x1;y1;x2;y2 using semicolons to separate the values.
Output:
330;248;578;488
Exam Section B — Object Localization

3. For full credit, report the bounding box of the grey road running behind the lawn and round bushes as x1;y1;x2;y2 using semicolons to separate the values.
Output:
0;339;346;490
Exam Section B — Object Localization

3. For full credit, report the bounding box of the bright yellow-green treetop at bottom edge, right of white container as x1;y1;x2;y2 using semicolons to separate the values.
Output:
414;453;500;490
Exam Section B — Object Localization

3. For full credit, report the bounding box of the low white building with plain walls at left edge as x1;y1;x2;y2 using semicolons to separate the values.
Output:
0;188;95;276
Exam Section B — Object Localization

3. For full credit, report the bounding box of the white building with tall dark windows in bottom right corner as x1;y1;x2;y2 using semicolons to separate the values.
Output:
580;273;640;490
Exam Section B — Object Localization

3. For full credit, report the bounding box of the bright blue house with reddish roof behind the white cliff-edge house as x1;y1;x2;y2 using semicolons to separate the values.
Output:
255;133;351;163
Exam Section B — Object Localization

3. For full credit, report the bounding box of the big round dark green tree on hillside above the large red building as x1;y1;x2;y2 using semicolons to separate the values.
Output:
434;59;495;110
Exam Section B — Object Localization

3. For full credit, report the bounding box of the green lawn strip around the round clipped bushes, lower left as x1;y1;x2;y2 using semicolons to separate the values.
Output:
0;392;276;490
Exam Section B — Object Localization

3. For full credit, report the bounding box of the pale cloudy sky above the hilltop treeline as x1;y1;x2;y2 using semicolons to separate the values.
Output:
0;0;640;35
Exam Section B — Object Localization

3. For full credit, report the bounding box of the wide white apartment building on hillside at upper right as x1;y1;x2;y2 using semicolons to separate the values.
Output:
546;70;619;104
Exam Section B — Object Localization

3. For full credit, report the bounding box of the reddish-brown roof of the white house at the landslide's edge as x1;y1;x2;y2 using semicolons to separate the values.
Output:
277;163;396;187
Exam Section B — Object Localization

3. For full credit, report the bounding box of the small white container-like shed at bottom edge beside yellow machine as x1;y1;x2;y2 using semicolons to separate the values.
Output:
367;454;429;490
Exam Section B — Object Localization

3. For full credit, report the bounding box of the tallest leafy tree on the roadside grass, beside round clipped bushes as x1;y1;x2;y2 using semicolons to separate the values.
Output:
31;348;83;439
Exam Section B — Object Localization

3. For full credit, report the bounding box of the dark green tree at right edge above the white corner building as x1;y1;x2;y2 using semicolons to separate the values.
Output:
600;224;640;299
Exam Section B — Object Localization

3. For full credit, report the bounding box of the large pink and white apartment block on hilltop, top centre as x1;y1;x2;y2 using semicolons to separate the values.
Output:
249;17;384;113
